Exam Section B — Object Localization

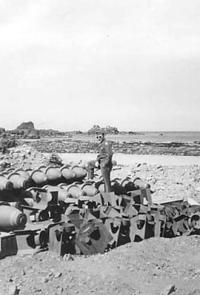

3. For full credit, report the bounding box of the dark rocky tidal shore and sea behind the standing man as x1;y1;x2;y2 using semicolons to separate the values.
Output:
21;132;200;156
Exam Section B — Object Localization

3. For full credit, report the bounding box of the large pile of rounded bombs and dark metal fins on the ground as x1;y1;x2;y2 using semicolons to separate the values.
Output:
0;166;200;258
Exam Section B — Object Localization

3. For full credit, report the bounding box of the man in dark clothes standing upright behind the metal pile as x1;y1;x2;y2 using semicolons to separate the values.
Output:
95;132;113;192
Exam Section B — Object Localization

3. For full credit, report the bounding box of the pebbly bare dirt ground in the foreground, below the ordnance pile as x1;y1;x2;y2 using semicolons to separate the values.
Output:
0;236;200;295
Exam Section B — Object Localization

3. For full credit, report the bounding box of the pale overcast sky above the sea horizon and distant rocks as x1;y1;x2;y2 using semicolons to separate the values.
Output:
0;0;200;131
